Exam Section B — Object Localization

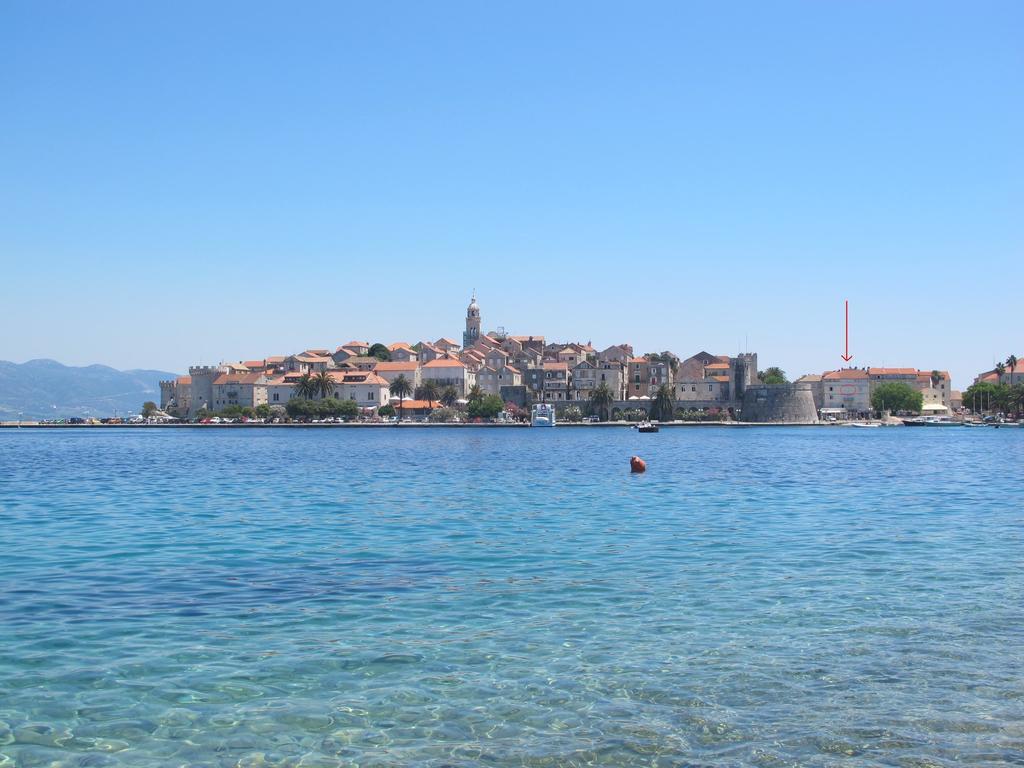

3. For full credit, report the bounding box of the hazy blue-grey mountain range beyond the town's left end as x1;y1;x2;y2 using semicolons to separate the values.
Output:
0;360;177;421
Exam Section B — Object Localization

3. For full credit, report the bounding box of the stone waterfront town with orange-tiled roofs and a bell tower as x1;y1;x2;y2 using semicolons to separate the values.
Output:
146;290;1024;423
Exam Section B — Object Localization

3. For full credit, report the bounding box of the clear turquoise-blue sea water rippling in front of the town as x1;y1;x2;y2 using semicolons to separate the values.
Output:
0;428;1024;766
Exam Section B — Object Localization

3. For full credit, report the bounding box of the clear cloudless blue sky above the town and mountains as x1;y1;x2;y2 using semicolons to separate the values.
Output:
0;0;1024;386
